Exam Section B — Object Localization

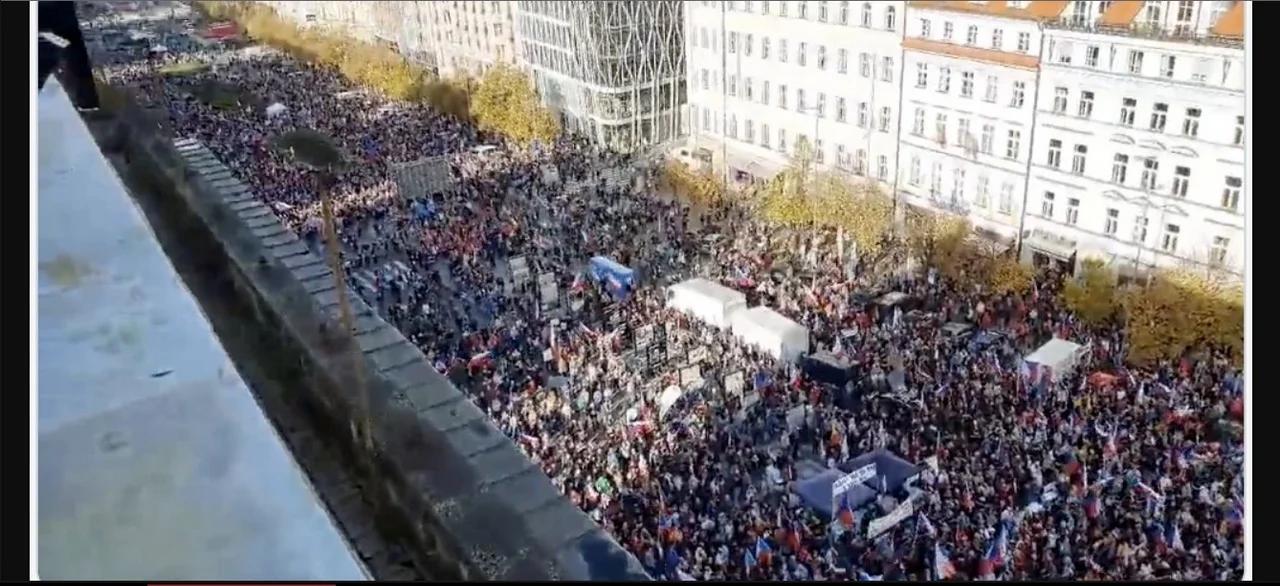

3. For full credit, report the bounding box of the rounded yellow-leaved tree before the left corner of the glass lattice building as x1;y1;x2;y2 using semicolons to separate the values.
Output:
471;64;559;146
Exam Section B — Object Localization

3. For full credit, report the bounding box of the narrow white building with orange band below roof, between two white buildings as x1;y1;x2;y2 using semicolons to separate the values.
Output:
897;1;1066;244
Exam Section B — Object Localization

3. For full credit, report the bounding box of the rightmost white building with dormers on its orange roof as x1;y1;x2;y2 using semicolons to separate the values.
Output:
1023;1;1247;275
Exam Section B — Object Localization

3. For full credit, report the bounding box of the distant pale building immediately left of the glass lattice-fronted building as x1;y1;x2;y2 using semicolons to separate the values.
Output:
416;0;517;77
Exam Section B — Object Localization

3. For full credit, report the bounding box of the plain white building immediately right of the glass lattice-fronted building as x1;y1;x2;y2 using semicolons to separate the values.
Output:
685;0;905;187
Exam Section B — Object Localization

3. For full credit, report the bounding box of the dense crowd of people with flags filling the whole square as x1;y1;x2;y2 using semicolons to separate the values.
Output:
94;10;1244;580
